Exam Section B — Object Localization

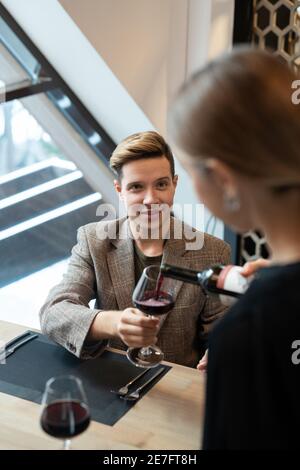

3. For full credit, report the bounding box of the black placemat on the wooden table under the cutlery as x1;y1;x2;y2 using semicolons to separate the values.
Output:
0;335;170;426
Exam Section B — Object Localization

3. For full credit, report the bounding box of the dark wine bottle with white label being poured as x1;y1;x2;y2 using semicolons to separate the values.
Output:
160;264;253;305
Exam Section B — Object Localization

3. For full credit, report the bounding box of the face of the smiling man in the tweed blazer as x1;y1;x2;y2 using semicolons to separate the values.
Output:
115;157;178;234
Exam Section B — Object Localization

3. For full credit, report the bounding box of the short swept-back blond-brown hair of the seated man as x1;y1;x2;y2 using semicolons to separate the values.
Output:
110;131;175;178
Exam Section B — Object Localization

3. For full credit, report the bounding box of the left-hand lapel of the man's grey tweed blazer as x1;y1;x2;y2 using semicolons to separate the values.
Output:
107;219;135;310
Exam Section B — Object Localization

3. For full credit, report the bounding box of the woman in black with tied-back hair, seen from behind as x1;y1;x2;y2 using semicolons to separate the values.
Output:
170;49;300;449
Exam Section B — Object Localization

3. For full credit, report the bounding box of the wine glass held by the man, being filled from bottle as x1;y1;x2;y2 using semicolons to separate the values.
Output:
127;265;177;368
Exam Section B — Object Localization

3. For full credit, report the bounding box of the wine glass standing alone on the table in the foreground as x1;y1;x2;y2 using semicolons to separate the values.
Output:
41;375;90;450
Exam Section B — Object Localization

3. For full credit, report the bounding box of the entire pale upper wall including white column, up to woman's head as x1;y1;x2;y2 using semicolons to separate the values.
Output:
60;0;234;135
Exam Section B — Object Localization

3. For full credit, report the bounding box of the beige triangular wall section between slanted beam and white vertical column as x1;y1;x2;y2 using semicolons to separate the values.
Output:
60;0;175;136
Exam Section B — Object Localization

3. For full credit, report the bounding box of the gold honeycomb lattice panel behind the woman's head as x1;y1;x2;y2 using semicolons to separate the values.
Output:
240;0;300;264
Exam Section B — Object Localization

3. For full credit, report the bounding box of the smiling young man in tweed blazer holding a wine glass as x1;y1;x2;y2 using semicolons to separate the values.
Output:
40;131;230;367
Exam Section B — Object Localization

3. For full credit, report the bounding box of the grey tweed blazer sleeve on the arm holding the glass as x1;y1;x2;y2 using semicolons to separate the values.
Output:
40;227;107;359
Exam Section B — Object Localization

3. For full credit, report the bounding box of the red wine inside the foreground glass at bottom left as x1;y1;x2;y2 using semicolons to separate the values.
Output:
41;400;90;439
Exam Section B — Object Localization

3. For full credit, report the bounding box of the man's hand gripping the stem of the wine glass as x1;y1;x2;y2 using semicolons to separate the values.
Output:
116;308;159;348
